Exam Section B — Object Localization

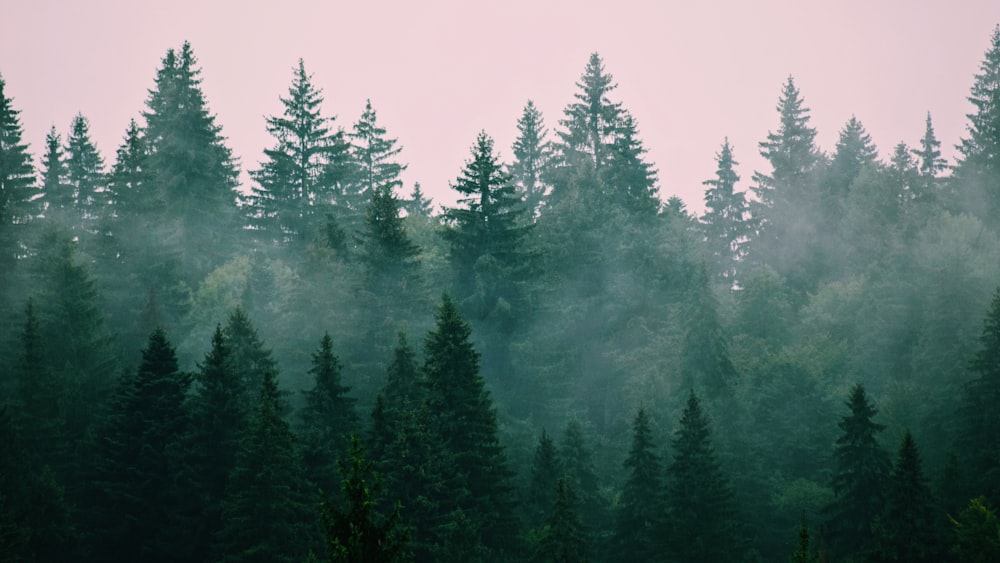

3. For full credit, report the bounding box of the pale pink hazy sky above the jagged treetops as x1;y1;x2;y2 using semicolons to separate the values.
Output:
0;0;1000;214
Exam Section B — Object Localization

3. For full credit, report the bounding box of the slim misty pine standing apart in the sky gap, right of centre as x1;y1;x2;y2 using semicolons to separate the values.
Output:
701;137;751;283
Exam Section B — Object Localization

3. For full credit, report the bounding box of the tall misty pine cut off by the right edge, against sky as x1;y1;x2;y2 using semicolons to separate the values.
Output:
954;25;1000;224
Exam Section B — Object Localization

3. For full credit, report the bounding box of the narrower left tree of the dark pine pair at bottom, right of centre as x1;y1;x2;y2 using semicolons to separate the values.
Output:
613;407;666;562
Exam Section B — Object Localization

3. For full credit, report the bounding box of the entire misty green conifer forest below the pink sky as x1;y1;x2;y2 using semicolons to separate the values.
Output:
0;26;1000;563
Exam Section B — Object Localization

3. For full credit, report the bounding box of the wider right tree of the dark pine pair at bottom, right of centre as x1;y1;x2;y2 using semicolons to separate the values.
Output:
666;392;742;562
